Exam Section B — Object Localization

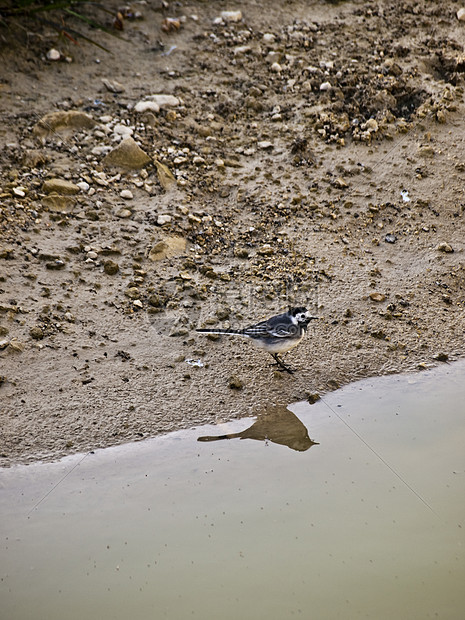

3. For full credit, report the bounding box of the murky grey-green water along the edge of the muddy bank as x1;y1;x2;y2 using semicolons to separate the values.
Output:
0;362;465;620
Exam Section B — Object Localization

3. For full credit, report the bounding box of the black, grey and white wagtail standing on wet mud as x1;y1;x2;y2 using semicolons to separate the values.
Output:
196;307;318;374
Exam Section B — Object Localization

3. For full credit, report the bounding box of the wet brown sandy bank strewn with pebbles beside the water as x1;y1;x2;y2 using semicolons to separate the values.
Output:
0;0;465;466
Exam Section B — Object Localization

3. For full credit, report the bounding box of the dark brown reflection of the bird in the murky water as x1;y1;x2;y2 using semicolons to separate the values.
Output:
197;405;318;452
